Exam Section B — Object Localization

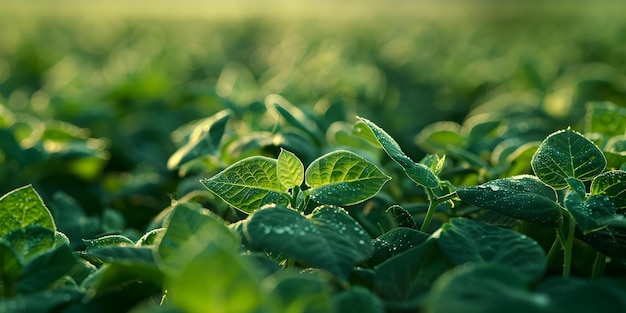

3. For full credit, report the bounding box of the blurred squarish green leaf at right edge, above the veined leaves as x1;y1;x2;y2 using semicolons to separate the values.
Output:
585;102;626;137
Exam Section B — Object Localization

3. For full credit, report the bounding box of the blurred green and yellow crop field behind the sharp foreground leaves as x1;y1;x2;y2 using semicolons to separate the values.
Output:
0;0;626;231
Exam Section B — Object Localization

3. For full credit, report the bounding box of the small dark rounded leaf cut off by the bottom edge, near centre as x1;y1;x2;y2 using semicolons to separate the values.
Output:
333;286;385;313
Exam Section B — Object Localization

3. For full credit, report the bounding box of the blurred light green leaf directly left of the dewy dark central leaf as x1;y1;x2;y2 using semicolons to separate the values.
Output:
158;203;241;271
